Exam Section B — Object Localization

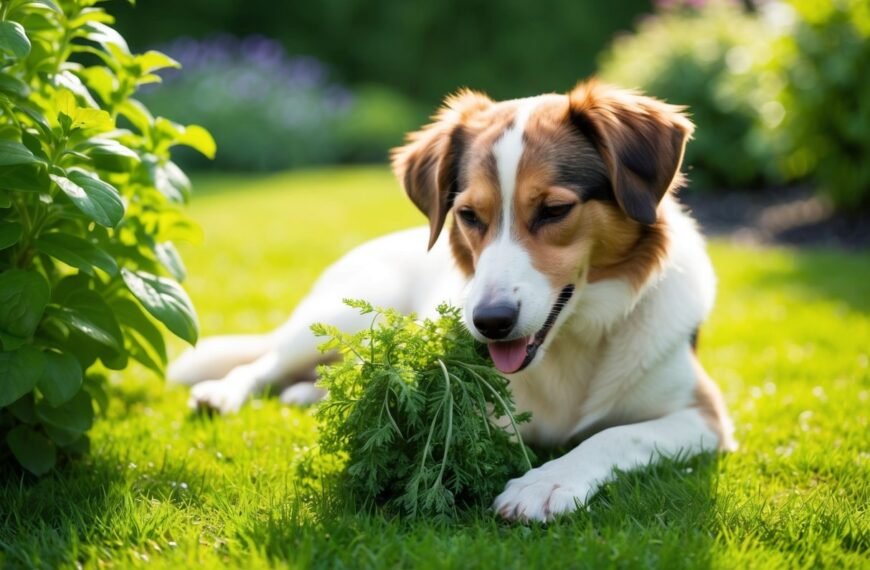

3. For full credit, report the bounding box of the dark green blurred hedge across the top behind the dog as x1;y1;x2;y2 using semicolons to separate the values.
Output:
109;0;650;103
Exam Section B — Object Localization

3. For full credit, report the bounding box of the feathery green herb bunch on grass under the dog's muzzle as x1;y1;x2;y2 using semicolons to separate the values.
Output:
313;301;532;518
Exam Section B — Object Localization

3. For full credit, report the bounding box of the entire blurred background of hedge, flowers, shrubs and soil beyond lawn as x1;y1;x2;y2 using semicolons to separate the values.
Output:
113;0;870;243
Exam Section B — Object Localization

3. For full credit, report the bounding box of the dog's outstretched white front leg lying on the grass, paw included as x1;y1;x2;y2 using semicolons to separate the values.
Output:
493;408;719;521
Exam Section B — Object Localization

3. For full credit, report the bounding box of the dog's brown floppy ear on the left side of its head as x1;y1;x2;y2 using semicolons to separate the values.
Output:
391;90;492;249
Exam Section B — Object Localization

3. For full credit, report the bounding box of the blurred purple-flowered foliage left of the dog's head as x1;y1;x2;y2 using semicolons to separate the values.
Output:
136;35;426;170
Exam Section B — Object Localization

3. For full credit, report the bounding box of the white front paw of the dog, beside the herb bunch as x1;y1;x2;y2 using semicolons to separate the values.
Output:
493;464;597;522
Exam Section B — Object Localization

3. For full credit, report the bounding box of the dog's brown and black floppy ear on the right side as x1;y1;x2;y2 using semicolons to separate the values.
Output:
568;80;694;225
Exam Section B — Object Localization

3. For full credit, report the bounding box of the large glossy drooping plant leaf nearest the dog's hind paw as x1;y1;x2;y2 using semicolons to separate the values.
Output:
121;268;199;344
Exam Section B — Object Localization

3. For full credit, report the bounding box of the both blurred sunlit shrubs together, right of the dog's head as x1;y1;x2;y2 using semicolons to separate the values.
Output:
601;0;870;209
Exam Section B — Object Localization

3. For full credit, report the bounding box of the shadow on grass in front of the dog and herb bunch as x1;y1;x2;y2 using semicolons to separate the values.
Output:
238;455;718;568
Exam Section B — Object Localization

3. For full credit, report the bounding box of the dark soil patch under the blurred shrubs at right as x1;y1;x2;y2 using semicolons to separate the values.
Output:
680;187;870;250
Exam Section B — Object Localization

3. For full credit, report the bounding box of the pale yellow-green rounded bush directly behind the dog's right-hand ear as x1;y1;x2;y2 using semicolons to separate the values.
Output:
600;1;772;188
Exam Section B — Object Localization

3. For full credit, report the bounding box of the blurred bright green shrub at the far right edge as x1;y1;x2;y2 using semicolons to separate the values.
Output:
757;0;870;209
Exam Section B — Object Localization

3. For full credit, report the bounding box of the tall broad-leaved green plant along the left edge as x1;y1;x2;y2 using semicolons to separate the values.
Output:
0;0;214;475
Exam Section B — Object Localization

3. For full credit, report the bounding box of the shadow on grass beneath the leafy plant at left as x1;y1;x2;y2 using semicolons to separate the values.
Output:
0;449;207;568
